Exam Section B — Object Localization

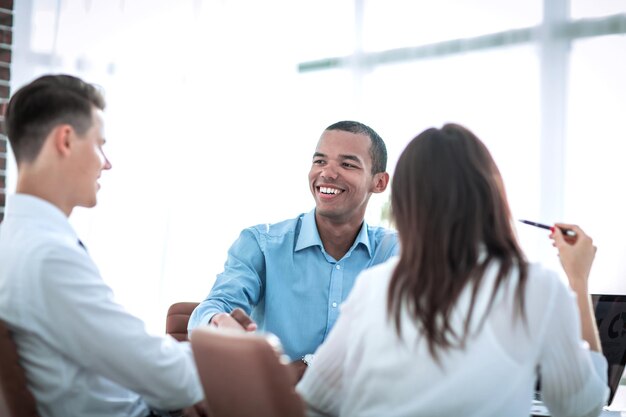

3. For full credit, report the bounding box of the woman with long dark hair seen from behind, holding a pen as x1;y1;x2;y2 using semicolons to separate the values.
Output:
298;124;608;417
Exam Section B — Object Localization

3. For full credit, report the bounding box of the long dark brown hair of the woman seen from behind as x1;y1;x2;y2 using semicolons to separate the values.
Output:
387;124;528;360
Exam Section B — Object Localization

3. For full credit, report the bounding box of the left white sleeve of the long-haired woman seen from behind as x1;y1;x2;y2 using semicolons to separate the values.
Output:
296;266;367;417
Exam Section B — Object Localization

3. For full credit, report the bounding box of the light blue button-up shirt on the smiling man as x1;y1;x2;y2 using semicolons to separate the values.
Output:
189;210;398;360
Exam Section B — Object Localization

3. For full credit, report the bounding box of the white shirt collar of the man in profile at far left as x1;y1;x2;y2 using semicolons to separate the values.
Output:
5;194;78;240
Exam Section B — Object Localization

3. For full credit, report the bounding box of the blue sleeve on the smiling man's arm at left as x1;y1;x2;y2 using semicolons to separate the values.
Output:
188;229;265;331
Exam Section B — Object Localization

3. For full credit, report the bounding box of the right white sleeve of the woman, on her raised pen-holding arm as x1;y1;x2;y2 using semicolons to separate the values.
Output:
540;285;609;417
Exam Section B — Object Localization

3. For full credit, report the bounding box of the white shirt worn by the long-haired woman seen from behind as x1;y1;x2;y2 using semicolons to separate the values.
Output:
297;258;608;417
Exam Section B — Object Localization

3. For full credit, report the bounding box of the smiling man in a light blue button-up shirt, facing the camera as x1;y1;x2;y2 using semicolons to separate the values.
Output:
189;121;398;370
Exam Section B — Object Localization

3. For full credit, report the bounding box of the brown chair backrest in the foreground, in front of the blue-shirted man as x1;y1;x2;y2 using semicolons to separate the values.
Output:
191;326;304;417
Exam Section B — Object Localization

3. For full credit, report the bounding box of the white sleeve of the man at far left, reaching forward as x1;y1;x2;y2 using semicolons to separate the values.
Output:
36;247;204;410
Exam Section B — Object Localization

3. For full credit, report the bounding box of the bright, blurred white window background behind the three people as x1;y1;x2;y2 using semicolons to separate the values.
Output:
6;0;626;333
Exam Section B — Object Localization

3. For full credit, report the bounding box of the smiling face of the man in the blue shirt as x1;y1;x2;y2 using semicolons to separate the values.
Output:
309;130;374;222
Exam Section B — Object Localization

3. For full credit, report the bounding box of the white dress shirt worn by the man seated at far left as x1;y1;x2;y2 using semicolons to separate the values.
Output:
0;194;204;417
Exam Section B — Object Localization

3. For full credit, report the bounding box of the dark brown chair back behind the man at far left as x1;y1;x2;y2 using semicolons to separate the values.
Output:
0;320;39;417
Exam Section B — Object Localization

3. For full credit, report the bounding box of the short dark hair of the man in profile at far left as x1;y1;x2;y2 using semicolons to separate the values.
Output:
5;74;105;163
